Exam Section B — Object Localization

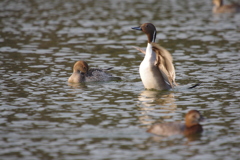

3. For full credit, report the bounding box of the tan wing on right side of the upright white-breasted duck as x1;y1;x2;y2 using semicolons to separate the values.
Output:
152;43;177;88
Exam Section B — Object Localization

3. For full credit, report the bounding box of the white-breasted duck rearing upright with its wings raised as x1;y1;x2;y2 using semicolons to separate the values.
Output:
132;23;177;90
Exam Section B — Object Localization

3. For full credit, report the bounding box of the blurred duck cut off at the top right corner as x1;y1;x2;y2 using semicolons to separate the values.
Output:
212;0;240;13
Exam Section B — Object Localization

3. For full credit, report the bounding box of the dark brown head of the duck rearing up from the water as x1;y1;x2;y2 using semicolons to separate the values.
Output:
132;23;157;43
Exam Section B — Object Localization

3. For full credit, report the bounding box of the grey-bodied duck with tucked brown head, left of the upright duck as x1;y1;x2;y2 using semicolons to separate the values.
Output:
68;60;121;83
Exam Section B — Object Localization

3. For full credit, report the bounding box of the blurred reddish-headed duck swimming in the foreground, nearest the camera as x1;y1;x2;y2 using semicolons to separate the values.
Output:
147;110;204;136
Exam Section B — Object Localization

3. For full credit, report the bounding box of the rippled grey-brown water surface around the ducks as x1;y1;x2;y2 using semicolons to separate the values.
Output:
0;0;240;160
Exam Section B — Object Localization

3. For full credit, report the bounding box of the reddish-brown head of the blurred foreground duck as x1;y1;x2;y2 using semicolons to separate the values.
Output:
185;110;203;127
